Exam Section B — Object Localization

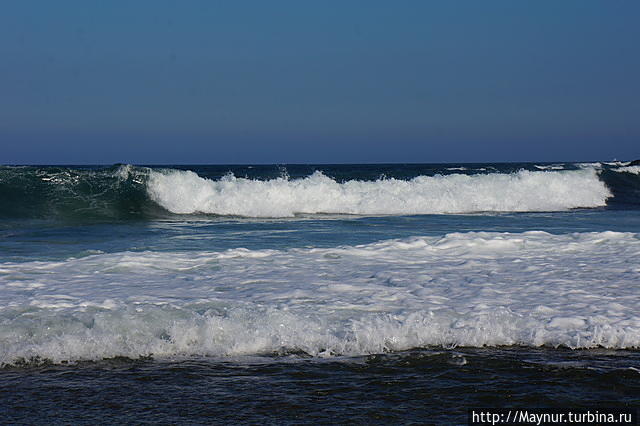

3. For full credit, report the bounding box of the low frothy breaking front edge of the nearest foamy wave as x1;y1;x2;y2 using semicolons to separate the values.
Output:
0;305;640;366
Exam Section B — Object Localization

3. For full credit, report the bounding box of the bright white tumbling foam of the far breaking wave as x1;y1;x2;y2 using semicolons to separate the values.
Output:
147;169;611;217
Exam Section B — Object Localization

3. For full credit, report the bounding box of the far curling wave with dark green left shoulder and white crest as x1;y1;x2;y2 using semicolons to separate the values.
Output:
0;163;640;221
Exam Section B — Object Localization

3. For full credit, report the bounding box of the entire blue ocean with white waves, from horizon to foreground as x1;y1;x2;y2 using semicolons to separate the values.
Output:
0;161;640;424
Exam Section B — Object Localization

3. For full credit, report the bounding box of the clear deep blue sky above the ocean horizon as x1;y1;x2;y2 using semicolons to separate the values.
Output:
0;0;640;164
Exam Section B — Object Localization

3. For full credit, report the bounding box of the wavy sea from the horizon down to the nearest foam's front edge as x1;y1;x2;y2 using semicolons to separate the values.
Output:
0;163;640;365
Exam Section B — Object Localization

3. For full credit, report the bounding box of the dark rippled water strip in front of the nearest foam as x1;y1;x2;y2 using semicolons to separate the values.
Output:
0;348;640;424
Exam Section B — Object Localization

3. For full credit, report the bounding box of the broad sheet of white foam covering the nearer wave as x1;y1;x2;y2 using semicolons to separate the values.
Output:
0;232;640;364
